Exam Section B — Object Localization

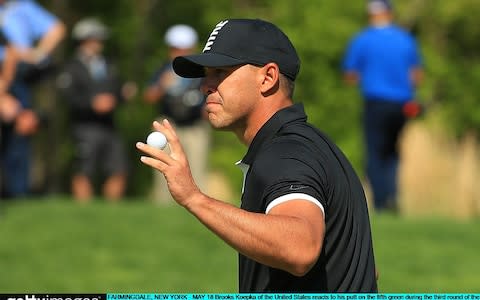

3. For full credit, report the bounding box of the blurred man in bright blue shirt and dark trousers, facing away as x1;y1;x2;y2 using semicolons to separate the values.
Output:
343;0;422;212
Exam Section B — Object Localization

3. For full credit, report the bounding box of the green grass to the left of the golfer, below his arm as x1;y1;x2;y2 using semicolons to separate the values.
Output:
0;200;237;292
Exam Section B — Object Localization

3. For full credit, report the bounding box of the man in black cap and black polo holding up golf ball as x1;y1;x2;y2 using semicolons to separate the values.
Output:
137;19;377;293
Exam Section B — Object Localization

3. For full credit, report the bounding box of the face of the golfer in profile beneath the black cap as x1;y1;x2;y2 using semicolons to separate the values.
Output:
201;65;261;132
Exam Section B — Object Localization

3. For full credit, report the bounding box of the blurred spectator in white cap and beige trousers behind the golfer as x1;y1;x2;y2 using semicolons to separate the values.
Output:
144;24;210;203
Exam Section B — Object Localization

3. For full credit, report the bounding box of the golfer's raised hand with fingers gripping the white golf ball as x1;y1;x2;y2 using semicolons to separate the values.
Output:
136;120;201;206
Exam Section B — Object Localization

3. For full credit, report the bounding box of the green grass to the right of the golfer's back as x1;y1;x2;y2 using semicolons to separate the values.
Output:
371;215;480;293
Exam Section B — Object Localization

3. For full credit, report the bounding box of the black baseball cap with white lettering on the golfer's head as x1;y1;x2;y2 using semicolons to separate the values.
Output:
173;19;300;80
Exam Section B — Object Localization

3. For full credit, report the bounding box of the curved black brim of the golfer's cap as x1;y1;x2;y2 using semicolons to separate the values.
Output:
173;53;246;78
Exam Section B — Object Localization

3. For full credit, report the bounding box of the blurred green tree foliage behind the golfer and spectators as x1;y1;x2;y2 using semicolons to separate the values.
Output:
36;0;480;198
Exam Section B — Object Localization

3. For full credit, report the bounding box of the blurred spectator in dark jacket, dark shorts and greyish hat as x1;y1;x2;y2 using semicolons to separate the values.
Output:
57;18;135;202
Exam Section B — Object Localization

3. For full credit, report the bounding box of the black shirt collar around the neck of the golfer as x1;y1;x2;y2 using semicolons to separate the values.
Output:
242;103;307;165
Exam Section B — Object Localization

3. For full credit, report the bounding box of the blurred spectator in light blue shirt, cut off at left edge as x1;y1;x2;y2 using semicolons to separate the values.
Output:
0;0;65;198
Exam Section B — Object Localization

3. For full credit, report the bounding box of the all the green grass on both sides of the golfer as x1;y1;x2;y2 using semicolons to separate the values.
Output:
0;198;480;293
